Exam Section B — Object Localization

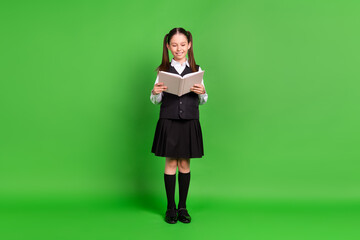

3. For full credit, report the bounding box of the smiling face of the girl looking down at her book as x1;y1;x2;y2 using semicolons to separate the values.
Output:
166;33;191;62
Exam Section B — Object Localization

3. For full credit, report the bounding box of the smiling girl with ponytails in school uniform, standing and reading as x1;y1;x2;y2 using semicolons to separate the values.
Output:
150;28;208;223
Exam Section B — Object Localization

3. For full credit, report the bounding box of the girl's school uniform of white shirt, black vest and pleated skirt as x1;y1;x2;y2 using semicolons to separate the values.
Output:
150;59;208;158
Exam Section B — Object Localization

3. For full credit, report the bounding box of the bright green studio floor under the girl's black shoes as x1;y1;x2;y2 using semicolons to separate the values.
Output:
0;196;360;240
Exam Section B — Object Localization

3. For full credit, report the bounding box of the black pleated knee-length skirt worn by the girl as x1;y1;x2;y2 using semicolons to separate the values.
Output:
151;118;204;158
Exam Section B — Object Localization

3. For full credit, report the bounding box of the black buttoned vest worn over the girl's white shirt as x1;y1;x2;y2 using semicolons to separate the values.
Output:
160;64;199;119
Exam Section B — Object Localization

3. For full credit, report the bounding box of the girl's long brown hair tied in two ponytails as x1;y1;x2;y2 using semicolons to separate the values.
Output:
155;28;198;72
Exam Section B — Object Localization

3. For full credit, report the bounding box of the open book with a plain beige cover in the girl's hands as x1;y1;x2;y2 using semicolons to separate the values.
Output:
159;70;204;97
